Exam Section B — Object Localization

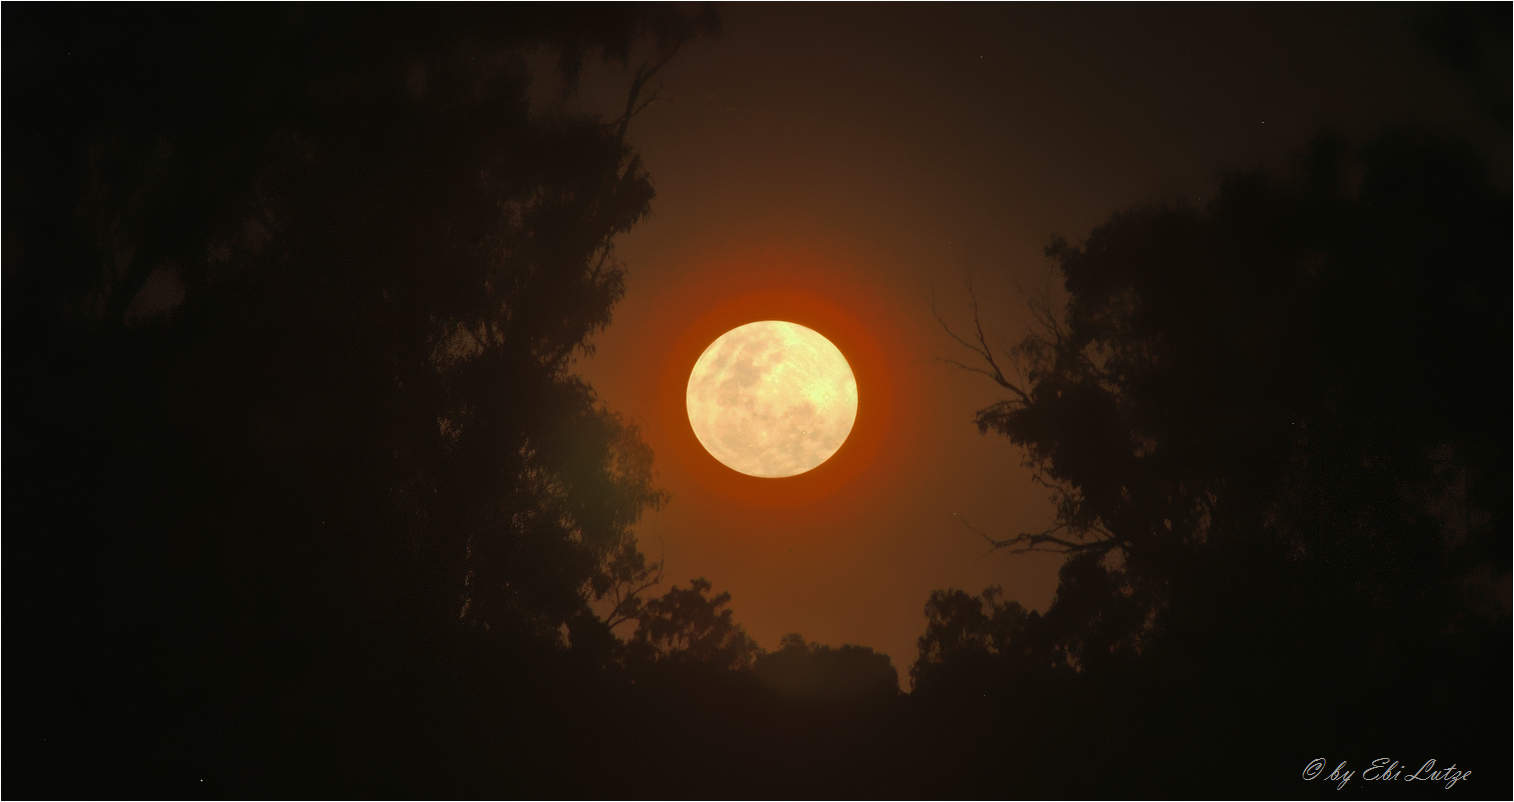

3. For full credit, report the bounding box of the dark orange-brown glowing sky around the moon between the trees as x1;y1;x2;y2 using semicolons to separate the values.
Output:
544;5;1508;675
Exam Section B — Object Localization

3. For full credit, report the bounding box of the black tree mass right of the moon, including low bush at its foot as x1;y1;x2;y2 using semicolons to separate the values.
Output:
913;129;1511;792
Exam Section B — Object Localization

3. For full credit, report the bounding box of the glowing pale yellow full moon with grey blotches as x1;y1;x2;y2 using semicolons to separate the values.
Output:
687;321;857;478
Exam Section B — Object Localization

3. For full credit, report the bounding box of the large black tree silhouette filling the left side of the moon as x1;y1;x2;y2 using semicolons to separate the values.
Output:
5;6;713;796
